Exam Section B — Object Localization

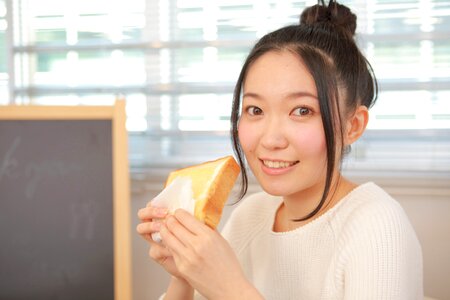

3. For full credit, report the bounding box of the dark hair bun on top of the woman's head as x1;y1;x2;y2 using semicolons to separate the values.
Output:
300;1;356;36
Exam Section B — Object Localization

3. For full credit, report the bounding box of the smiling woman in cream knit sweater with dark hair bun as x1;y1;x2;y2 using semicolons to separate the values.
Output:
137;1;423;299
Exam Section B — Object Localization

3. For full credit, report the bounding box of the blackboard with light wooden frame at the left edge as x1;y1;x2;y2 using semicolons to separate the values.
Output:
0;103;130;299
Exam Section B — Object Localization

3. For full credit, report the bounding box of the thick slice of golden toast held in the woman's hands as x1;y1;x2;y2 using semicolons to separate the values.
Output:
166;156;240;229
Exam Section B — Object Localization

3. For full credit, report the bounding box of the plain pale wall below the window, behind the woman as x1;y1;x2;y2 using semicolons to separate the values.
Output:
131;178;450;300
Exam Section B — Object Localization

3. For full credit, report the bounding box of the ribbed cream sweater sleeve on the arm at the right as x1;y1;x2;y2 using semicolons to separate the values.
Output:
339;196;423;300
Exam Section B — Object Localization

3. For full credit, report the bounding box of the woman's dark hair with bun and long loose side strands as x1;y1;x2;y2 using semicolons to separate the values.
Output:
231;1;378;220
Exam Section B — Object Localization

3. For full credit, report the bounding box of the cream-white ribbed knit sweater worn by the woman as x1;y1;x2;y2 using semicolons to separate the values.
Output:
214;183;423;300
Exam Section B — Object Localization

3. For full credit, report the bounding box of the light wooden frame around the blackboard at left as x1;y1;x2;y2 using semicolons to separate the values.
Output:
0;100;132;300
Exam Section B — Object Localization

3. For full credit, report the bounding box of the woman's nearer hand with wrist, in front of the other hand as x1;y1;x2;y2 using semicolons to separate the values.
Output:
160;209;259;299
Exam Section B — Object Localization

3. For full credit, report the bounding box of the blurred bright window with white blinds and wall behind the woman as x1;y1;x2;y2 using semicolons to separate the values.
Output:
0;0;450;300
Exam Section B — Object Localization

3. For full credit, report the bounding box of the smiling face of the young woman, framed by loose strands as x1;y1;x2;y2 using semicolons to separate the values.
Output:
238;51;327;196
